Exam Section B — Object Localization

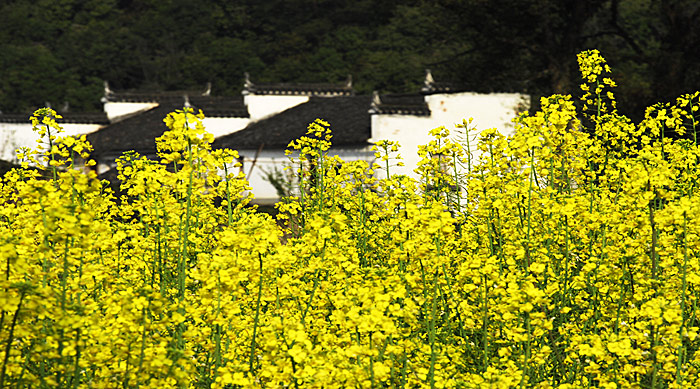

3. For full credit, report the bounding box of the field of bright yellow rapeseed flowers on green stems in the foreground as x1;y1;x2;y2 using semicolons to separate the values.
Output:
0;51;700;388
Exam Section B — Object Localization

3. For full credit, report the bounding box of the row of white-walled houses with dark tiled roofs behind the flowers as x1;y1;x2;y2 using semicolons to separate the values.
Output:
0;71;529;204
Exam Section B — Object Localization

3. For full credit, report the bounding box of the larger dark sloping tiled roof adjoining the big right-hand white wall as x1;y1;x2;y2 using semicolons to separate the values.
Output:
213;96;371;150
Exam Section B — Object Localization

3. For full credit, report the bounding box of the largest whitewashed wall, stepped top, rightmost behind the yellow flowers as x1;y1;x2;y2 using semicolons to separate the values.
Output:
372;93;528;178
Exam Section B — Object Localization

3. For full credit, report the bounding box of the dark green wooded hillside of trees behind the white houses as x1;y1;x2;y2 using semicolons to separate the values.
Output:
0;0;700;119
